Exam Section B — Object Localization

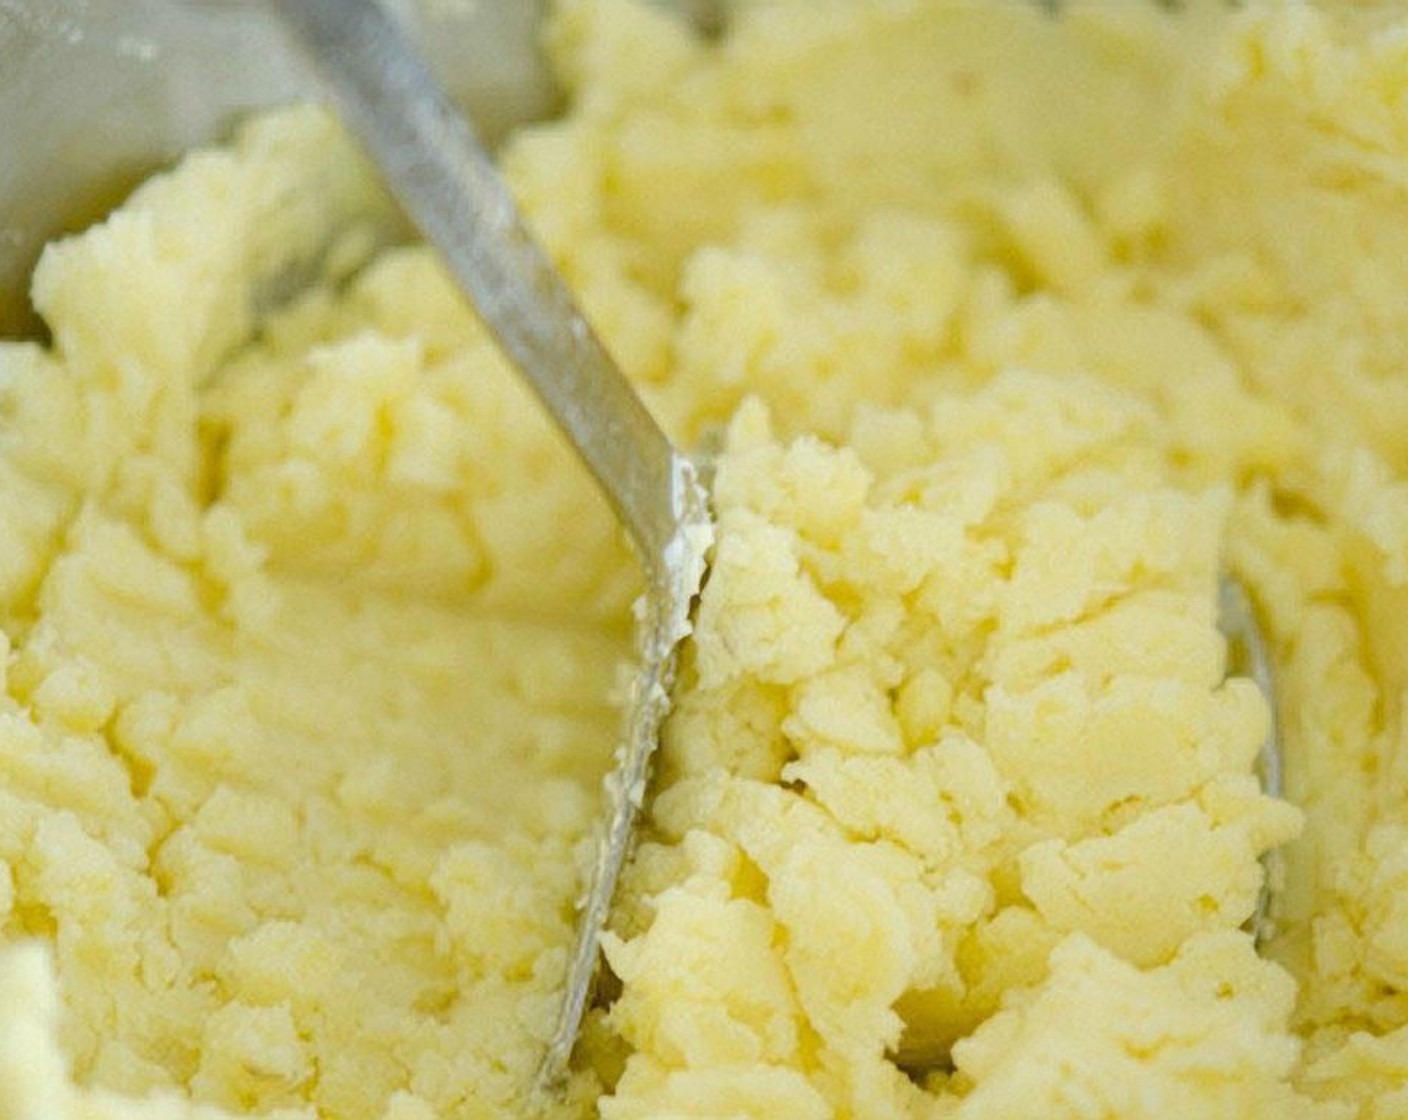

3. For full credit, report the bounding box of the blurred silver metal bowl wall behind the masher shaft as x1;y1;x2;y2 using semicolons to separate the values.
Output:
0;0;558;337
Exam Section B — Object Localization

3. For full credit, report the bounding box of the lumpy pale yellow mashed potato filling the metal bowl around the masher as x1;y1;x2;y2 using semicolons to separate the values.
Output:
0;0;1408;1120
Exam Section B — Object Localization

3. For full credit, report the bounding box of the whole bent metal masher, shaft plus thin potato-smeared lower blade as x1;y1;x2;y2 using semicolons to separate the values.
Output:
277;0;710;1085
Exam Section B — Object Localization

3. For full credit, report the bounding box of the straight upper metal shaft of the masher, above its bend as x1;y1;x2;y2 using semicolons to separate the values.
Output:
276;0;679;573
